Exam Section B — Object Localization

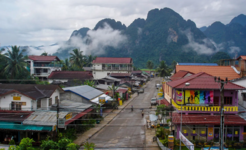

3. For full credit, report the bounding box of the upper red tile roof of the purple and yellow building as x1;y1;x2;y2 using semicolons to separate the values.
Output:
167;72;245;90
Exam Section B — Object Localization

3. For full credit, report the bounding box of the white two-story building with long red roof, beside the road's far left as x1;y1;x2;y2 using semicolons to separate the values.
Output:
92;57;133;79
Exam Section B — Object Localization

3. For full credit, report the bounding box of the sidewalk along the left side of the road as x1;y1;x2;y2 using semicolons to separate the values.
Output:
74;93;137;145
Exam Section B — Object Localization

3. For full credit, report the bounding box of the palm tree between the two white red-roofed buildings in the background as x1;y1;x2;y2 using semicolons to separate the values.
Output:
70;48;84;70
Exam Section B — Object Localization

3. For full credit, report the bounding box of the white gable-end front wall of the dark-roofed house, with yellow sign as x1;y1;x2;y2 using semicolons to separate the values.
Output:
0;93;32;111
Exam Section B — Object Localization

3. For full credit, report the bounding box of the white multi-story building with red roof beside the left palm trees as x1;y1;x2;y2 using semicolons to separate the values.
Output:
26;55;62;79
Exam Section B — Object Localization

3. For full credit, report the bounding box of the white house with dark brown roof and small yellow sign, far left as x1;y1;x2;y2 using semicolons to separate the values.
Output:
0;84;63;111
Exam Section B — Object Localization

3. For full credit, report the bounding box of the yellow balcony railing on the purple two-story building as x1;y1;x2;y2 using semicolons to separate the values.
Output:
172;100;238;112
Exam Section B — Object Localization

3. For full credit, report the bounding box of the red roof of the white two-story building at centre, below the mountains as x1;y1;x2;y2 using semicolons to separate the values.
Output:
92;57;132;64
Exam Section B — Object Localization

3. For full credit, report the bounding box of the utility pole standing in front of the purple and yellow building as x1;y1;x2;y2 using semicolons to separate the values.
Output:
214;77;228;150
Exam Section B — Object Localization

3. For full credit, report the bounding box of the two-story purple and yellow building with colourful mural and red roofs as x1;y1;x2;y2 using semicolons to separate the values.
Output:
164;72;246;142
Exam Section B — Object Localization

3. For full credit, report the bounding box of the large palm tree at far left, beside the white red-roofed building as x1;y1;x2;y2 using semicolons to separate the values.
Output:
3;46;28;79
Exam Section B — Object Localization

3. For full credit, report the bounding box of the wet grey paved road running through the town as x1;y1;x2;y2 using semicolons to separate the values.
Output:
89;79;160;150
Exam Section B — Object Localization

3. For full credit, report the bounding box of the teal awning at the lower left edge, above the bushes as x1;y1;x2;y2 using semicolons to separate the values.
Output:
0;122;52;132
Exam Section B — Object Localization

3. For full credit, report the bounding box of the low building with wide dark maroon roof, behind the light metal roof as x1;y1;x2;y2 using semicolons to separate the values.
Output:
48;71;93;87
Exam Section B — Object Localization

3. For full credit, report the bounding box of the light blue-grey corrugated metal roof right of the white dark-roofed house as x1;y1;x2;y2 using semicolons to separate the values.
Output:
63;85;103;100
